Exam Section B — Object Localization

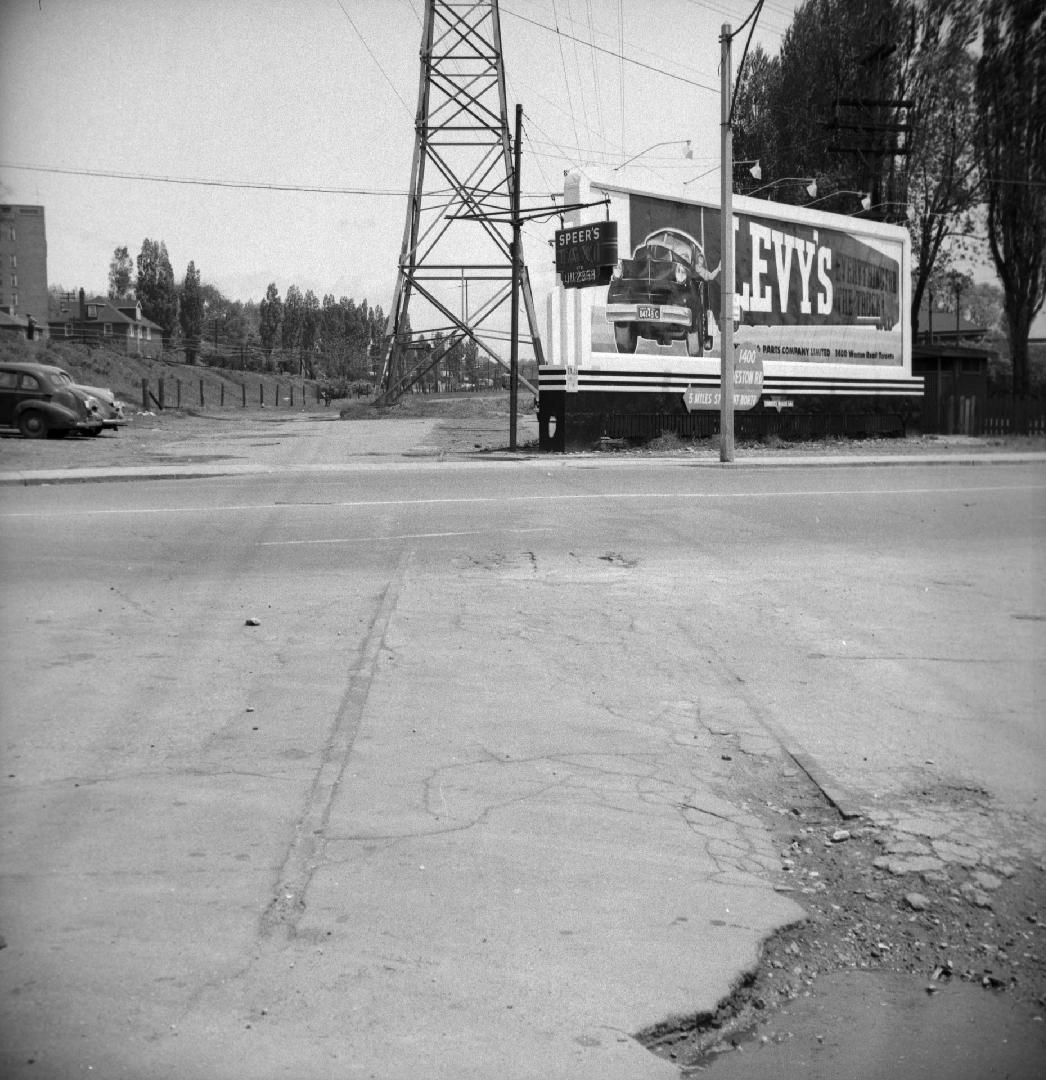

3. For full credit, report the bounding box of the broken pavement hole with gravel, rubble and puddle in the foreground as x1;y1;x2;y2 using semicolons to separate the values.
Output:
637;743;1046;1080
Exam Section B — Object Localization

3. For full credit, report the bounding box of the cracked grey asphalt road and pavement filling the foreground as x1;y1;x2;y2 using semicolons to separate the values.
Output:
0;458;1046;1080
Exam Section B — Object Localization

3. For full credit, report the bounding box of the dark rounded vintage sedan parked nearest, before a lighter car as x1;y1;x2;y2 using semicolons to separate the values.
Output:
0;362;103;438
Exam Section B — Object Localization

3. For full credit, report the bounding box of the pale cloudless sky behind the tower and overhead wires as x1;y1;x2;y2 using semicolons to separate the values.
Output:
0;0;794;311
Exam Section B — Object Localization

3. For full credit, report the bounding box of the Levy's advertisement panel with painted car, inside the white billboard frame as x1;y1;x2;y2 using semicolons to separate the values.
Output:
592;191;908;368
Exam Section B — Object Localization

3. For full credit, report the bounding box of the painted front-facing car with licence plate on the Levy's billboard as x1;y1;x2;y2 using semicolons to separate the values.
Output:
607;229;718;356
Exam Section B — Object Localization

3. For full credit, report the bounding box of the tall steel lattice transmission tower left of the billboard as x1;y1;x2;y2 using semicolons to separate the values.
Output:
379;0;543;403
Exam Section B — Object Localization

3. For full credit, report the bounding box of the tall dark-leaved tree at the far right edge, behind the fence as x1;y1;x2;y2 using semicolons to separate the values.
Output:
977;0;1046;396
